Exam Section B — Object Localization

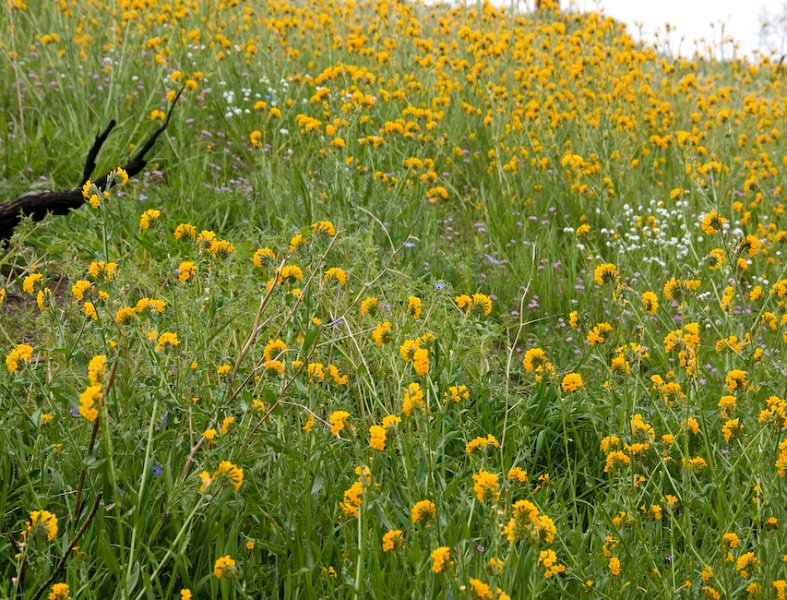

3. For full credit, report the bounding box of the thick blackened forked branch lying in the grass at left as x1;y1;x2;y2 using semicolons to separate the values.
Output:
0;88;185;242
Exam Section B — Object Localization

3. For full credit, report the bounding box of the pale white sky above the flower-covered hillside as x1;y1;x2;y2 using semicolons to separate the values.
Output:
572;0;787;58
